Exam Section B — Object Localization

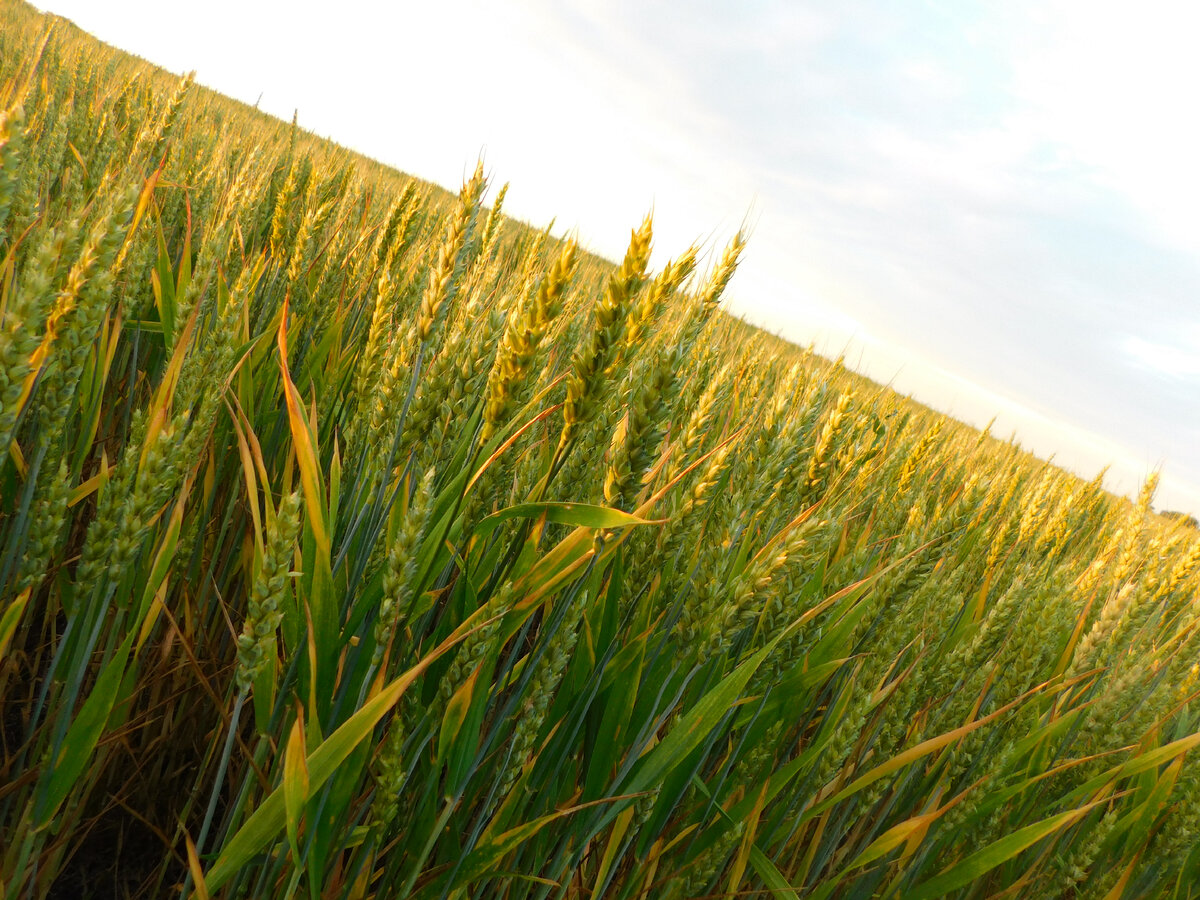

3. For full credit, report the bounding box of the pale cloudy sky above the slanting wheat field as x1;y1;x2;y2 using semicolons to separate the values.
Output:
28;0;1200;515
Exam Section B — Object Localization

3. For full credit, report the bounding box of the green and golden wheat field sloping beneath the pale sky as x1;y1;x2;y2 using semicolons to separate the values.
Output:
0;0;1200;900
